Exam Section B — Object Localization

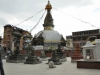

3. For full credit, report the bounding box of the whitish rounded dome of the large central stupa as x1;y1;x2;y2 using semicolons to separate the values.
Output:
35;30;62;42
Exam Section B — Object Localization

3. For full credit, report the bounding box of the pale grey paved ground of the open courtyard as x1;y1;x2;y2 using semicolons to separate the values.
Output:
3;58;100;75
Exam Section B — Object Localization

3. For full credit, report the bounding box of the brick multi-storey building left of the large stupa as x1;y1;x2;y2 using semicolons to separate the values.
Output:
3;24;32;53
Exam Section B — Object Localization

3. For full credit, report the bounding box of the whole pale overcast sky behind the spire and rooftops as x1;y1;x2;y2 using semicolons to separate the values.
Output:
0;0;100;37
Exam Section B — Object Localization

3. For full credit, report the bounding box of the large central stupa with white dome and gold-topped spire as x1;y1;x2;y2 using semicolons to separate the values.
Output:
32;1;66;56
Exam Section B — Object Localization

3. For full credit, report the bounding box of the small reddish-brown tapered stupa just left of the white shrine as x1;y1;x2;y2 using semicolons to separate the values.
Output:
71;43;83;62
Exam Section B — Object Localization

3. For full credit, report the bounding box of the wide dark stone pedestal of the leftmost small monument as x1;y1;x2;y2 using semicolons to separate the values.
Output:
6;54;25;63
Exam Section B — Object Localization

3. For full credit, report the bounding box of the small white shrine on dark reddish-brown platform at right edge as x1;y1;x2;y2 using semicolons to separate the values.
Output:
77;39;100;69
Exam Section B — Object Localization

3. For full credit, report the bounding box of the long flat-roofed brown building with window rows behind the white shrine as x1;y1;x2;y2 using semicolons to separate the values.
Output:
72;29;100;47
